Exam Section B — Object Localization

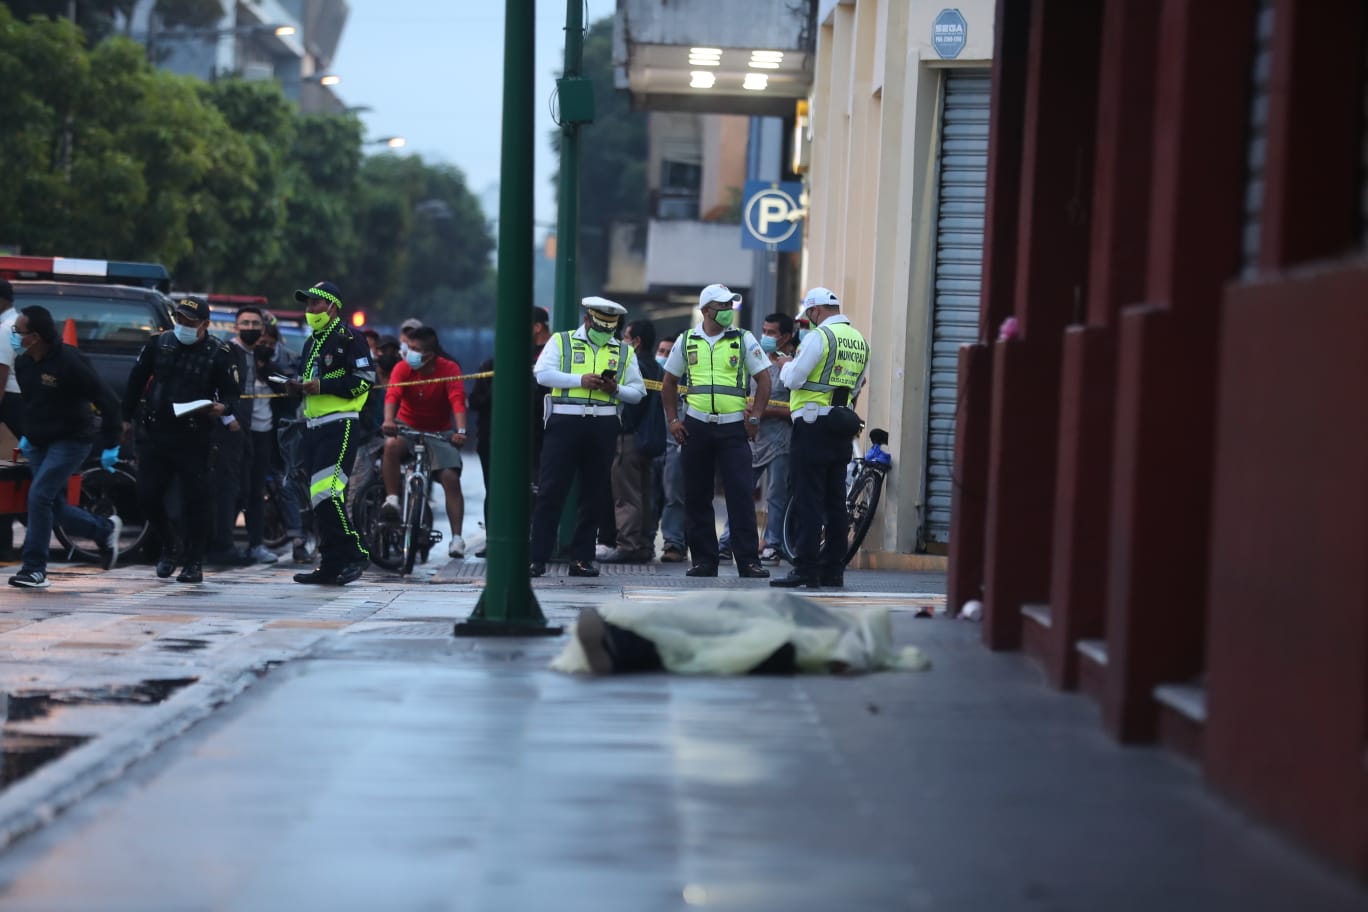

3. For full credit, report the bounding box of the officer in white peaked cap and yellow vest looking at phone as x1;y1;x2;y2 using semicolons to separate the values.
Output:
528;297;646;577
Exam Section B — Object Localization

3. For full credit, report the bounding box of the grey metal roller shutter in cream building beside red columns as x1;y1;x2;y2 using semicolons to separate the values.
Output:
922;70;992;543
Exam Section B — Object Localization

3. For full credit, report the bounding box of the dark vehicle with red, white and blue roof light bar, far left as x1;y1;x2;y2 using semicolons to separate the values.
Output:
0;256;172;399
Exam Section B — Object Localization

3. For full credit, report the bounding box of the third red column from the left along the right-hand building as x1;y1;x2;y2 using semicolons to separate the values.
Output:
1044;0;1159;688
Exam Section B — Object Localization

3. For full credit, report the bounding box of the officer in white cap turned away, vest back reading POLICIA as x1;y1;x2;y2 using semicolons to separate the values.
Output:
770;287;869;589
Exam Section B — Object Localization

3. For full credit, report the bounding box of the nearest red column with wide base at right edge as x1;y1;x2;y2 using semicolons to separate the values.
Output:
1204;0;1368;876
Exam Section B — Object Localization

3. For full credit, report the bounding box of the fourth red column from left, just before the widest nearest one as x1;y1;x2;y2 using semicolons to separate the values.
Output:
1103;0;1254;740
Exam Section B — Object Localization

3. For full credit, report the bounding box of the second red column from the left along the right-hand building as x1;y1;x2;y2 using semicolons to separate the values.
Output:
984;0;1101;649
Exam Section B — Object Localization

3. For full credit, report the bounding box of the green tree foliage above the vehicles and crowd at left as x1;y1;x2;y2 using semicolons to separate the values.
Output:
0;4;494;324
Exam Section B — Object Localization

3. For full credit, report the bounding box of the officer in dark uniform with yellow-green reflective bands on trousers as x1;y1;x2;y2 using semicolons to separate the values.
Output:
287;282;375;585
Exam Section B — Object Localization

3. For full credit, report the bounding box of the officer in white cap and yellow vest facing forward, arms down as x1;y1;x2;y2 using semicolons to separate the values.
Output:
661;284;770;578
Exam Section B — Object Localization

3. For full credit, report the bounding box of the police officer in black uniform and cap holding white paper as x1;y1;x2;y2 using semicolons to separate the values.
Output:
123;298;239;582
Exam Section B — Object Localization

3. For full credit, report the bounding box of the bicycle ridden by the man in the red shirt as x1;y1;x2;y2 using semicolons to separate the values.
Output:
352;428;446;576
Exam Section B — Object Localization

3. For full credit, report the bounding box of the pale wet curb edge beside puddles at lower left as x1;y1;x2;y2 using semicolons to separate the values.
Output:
0;658;278;849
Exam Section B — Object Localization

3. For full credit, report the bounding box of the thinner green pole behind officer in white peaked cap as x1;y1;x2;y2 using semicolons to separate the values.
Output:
549;0;584;554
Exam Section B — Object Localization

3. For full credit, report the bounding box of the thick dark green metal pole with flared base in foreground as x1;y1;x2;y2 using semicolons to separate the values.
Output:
454;0;561;636
